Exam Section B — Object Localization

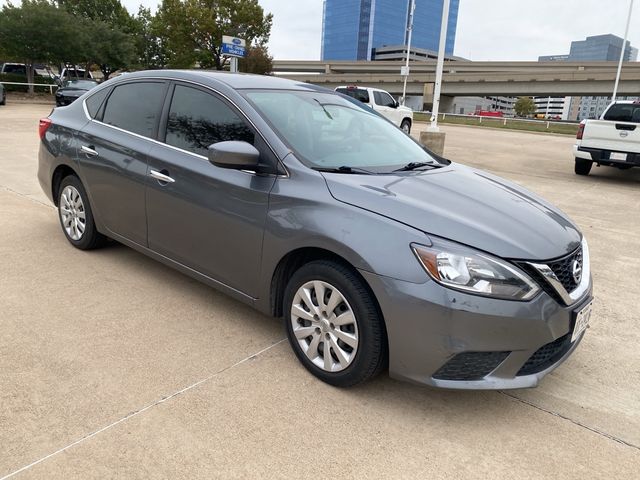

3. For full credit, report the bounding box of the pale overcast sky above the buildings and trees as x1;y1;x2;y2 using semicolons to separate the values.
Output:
0;0;640;61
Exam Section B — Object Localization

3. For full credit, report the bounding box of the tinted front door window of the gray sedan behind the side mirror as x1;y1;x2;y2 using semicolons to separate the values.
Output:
165;85;254;157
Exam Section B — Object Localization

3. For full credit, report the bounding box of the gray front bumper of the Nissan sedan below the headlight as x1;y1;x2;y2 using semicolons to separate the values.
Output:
361;271;591;389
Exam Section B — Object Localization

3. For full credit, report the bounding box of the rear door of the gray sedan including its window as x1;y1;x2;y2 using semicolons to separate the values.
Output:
78;80;168;246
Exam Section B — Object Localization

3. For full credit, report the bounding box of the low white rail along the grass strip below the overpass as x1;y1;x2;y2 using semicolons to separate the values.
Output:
414;111;580;134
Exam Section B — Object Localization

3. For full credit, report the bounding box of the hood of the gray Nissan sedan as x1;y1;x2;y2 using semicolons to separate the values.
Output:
323;164;581;260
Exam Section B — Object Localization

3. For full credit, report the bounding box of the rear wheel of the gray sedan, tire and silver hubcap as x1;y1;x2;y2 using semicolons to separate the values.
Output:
58;175;107;250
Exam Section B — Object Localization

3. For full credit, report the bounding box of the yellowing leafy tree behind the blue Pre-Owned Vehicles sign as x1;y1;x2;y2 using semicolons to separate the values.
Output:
156;0;273;70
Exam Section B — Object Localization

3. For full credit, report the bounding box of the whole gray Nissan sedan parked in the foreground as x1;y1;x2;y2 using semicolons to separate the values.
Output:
38;71;592;389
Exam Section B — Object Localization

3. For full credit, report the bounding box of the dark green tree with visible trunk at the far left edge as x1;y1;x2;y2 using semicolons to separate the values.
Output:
0;0;82;93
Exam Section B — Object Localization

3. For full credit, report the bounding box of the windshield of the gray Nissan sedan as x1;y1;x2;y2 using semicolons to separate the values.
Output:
245;90;438;173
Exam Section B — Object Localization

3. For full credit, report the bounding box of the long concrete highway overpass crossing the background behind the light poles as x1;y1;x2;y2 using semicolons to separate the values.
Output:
273;60;640;97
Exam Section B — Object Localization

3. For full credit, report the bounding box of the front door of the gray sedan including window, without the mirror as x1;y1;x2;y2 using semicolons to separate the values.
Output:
146;82;276;297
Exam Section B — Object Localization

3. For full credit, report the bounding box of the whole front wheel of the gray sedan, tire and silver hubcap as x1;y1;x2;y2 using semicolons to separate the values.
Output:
283;260;386;387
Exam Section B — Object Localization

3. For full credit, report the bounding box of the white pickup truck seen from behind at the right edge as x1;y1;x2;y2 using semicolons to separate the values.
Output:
573;100;640;175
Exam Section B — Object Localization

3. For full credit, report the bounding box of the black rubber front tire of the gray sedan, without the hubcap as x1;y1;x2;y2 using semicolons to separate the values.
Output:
283;260;387;387
